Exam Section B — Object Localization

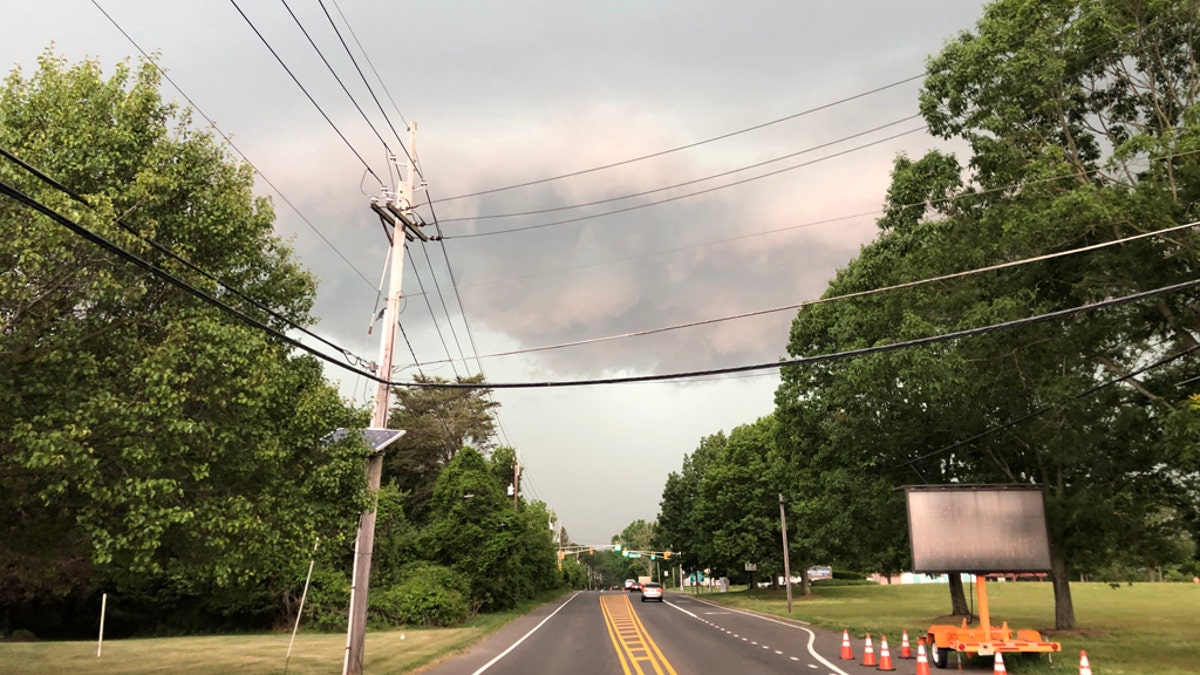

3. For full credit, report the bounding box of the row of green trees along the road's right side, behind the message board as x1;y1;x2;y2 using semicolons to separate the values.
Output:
659;0;1200;628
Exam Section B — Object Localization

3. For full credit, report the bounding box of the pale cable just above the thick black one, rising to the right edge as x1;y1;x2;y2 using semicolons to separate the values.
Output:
405;221;1200;363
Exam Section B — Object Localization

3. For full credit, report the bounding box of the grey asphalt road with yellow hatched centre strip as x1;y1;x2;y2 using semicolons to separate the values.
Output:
425;591;916;675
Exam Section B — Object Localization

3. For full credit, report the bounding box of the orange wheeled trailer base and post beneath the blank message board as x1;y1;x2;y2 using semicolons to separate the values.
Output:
925;574;1062;668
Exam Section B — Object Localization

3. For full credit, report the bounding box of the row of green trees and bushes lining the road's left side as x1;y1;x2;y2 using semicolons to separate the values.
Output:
0;52;558;637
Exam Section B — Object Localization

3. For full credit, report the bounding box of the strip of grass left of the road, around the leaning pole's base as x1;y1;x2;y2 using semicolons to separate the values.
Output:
0;588;566;675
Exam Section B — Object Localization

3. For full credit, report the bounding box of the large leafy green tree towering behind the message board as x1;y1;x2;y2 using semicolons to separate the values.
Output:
776;0;1200;628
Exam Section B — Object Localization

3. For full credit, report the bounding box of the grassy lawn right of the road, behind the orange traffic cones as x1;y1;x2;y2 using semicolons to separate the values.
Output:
702;583;1200;675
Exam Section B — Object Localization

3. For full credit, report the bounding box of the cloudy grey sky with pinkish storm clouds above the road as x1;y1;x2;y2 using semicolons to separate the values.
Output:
0;0;983;540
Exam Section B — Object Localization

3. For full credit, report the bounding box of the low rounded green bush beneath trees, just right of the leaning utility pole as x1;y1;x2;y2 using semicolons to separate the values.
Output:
370;563;470;628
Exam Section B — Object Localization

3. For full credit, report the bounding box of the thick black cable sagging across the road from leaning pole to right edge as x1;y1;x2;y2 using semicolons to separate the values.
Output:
395;273;1200;389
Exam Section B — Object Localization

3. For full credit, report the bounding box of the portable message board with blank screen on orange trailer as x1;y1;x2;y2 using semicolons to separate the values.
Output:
905;485;1062;668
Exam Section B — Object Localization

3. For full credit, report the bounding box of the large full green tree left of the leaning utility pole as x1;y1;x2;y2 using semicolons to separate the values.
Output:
0;53;365;621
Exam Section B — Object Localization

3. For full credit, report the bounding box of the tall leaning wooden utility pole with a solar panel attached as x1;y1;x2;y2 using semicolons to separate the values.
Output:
342;123;427;675
